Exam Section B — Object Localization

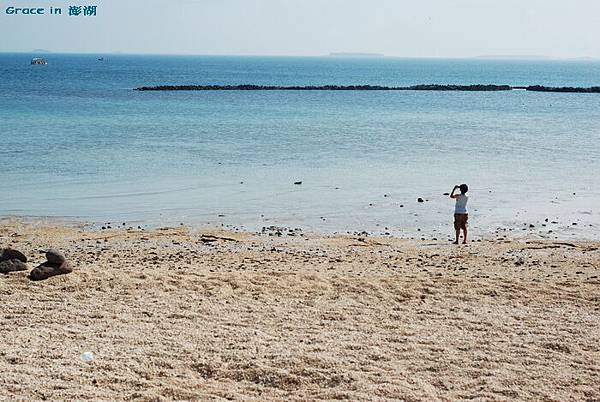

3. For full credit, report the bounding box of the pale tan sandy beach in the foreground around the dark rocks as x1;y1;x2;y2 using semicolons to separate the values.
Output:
0;220;600;401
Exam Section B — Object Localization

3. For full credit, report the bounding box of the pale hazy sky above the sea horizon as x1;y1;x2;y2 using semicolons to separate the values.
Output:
0;0;600;58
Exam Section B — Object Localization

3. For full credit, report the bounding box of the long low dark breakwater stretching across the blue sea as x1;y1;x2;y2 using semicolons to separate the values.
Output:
135;84;600;93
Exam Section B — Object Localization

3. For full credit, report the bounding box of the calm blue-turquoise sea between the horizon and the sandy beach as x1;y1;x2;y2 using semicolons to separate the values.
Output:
0;54;600;239
